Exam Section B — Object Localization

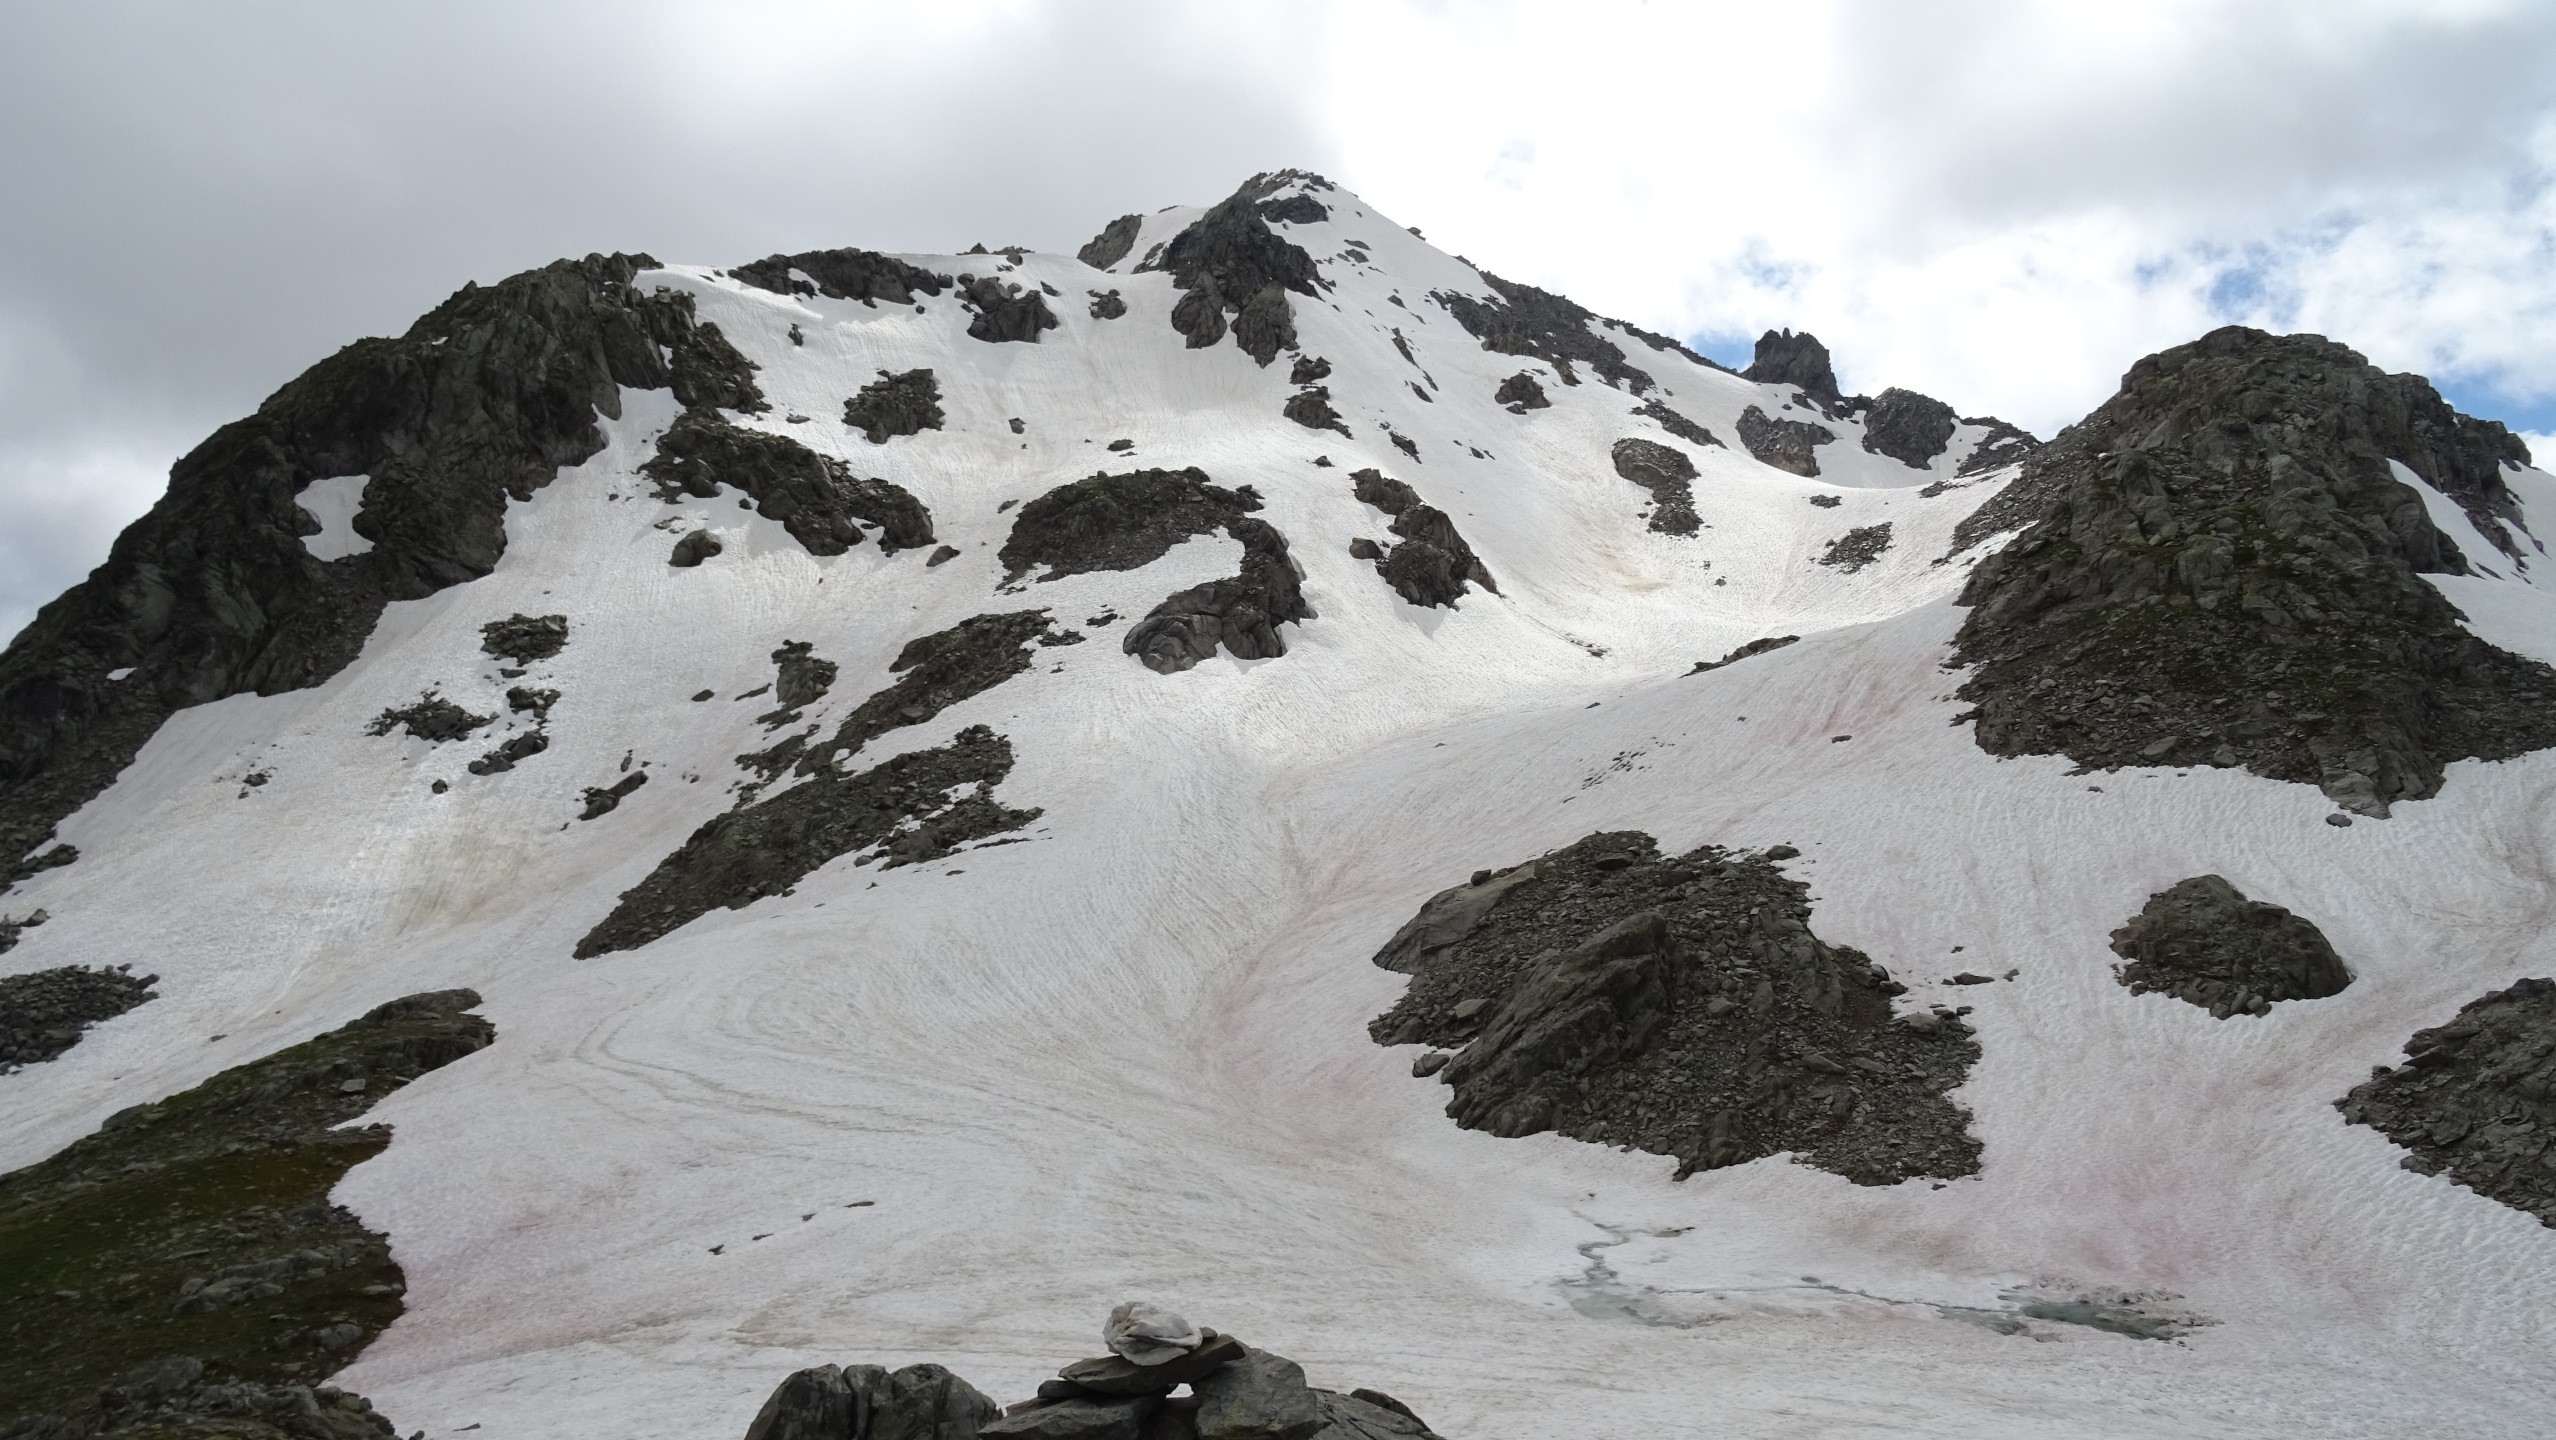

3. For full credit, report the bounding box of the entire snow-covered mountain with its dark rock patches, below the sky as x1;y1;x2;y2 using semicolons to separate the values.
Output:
0;171;2556;1440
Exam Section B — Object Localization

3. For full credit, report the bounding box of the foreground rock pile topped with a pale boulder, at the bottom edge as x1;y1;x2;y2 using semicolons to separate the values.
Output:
746;1302;1436;1440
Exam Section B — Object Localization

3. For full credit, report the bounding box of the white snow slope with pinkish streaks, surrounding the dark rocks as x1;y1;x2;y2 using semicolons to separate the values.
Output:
0;189;2556;1440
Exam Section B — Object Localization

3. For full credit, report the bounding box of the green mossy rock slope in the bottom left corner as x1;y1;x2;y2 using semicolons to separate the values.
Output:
0;990;493;1440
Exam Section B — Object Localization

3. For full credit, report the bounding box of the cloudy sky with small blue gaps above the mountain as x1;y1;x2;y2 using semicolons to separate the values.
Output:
0;0;2556;634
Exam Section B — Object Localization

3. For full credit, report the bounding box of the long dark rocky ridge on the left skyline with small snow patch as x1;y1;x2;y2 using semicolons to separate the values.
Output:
0;256;764;870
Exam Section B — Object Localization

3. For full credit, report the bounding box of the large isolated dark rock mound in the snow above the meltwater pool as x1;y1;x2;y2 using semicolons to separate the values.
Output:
1370;831;1978;1184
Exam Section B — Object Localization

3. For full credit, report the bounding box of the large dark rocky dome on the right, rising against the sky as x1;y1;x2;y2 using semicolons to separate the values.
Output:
1955;327;2556;816
